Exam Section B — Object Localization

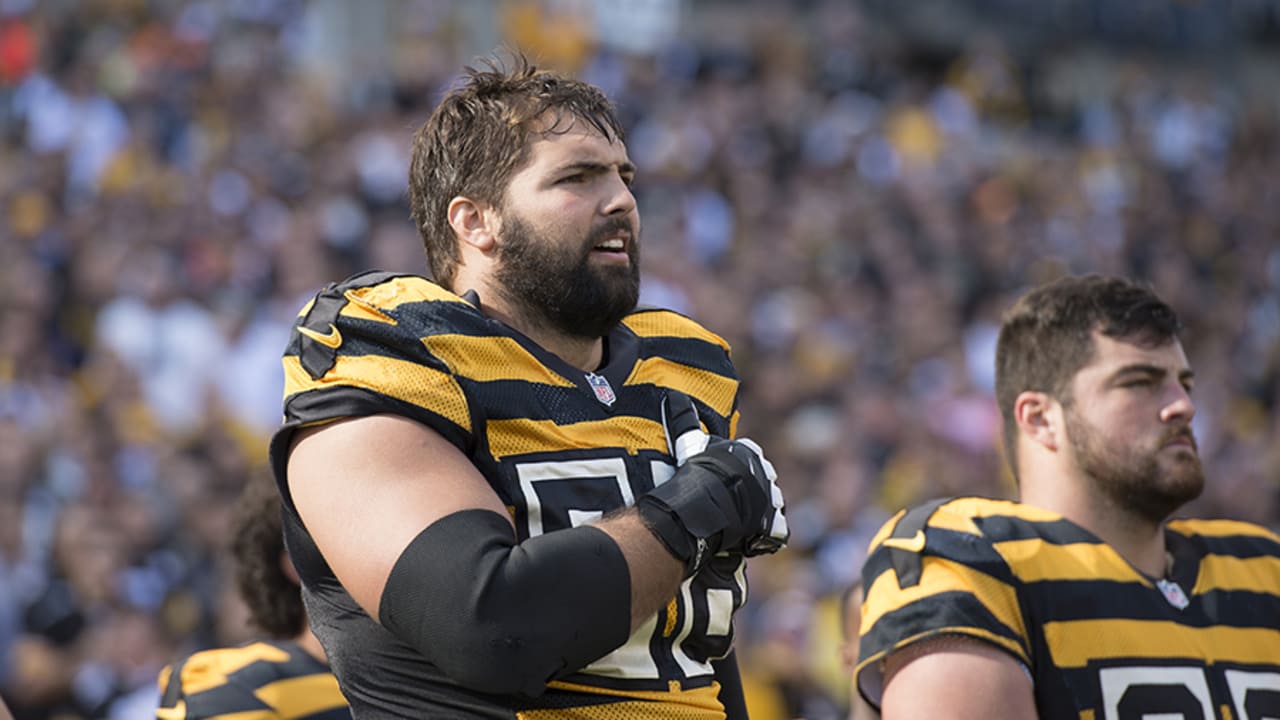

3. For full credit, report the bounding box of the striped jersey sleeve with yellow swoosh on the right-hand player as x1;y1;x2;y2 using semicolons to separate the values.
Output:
855;501;1032;706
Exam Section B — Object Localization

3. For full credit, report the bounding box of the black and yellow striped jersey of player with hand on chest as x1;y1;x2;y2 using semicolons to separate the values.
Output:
271;273;746;720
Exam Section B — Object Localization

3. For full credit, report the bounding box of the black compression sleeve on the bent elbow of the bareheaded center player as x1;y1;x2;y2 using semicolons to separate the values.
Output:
379;510;631;696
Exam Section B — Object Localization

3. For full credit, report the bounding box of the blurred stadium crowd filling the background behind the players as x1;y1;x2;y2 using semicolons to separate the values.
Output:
0;0;1280;720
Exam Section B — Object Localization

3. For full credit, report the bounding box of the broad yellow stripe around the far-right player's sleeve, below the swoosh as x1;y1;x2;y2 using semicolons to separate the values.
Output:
863;556;1028;653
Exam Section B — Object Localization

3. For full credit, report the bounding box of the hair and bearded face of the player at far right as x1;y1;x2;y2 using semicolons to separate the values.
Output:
996;275;1203;521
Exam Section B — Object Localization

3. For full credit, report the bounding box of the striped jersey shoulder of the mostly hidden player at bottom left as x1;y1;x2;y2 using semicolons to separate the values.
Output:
156;641;351;720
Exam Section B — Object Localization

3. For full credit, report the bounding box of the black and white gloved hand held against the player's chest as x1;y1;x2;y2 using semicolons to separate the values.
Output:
636;391;790;574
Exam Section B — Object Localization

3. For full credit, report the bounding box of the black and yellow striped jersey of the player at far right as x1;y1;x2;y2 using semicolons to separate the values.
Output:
856;497;1280;720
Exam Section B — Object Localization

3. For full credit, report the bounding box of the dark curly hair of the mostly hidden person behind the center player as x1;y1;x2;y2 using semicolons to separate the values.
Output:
230;475;300;639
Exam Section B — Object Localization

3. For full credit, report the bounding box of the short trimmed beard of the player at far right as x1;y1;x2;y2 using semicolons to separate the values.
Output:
1065;407;1204;524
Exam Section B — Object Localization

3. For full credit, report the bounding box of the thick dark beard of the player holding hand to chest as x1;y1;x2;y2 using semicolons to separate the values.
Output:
495;215;640;338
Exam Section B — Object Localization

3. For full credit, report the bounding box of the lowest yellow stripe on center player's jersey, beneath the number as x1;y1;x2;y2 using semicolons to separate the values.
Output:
516;682;724;720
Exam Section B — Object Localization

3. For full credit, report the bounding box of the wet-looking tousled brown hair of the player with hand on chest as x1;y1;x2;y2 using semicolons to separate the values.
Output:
408;53;623;286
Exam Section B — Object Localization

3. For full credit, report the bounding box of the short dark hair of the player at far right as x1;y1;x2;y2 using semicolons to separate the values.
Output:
996;274;1181;475
